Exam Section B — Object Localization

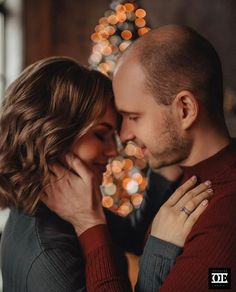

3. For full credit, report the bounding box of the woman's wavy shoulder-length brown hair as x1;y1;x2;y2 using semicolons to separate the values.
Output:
0;57;113;214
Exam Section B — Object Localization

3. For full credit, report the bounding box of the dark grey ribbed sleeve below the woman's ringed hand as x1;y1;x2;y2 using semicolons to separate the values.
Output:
135;235;182;292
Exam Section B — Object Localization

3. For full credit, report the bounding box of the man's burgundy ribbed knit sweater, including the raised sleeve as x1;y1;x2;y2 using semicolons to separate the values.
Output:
80;142;236;292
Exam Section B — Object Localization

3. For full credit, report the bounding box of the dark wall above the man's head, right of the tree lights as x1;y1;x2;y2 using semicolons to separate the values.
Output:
140;0;236;90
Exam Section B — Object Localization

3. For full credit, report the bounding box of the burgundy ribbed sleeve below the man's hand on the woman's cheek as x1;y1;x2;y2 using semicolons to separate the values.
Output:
79;225;131;292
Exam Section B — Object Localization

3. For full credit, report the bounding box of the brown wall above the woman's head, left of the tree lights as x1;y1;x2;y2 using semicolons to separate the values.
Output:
24;0;109;65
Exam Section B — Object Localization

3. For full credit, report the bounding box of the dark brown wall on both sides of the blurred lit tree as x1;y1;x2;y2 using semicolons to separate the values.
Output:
24;0;236;89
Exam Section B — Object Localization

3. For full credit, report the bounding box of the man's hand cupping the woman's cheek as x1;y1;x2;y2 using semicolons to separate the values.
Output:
42;153;106;236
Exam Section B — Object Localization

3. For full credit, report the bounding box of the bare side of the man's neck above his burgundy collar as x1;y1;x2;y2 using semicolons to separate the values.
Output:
180;128;230;166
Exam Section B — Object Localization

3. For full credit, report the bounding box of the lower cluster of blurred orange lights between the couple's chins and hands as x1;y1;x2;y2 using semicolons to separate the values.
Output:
100;142;147;216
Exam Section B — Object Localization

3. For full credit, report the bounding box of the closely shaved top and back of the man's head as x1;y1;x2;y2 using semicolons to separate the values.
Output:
117;25;223;117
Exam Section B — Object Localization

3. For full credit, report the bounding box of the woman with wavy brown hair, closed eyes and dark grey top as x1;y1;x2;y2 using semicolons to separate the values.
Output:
0;57;128;292
